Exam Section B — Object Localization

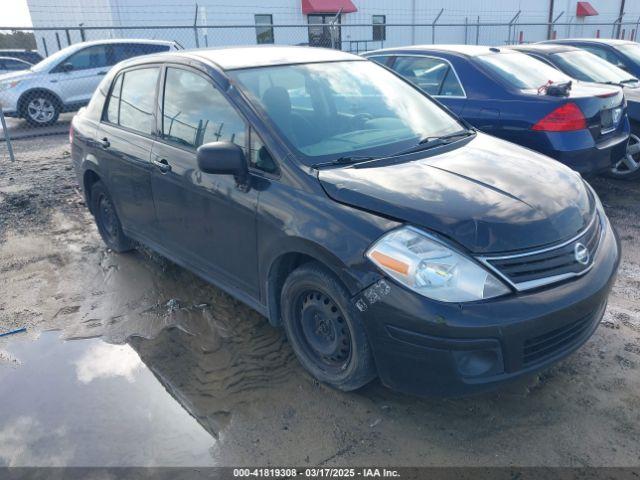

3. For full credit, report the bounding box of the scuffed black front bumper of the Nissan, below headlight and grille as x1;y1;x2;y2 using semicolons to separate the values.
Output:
354;223;620;396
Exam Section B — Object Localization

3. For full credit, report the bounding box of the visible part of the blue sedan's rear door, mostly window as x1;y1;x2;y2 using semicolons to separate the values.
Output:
389;55;467;114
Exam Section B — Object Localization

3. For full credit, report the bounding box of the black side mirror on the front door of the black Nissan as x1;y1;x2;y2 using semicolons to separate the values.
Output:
197;142;249;184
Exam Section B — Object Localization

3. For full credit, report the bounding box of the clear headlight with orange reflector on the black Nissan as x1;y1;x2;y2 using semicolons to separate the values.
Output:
366;227;510;302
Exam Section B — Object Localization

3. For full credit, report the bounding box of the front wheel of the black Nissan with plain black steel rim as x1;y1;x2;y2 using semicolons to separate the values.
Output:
280;262;377;391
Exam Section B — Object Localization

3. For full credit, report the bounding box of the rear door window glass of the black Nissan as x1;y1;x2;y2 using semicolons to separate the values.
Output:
107;67;159;134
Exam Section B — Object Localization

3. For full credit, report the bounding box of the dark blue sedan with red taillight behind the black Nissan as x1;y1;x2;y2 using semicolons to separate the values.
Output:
365;45;629;175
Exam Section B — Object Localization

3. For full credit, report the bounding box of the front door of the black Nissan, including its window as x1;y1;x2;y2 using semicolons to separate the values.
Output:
151;67;258;298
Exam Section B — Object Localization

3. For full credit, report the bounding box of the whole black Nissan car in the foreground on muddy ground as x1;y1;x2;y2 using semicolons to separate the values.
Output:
71;47;619;395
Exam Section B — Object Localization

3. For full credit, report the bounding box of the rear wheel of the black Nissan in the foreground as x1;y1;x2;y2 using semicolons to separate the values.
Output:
91;181;134;253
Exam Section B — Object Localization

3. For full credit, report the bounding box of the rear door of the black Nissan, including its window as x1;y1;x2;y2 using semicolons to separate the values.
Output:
98;65;160;239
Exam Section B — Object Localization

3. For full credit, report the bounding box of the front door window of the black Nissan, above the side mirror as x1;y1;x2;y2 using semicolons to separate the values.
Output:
162;68;246;148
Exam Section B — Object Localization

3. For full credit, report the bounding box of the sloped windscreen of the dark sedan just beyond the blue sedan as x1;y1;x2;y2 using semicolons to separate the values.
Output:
552;50;633;83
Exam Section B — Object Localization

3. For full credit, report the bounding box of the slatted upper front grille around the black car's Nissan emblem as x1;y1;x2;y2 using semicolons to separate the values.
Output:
483;214;602;290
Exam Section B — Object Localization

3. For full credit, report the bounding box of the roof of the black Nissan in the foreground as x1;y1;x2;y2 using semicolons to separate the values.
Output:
144;45;365;70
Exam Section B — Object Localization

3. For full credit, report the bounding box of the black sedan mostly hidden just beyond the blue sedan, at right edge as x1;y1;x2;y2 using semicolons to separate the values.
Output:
510;43;640;180
